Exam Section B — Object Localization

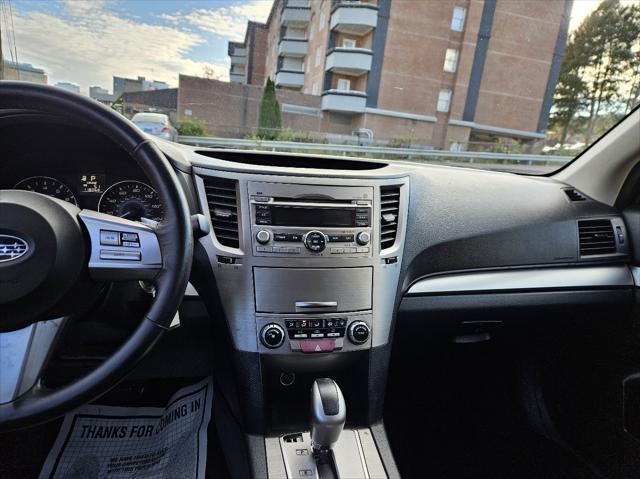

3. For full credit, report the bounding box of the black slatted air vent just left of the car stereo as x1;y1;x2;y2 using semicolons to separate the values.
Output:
204;178;240;248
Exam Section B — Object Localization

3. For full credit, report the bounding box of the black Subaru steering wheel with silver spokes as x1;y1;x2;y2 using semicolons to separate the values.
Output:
0;81;193;431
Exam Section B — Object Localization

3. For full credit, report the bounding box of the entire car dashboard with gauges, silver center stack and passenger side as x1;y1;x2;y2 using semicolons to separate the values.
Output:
0;113;634;476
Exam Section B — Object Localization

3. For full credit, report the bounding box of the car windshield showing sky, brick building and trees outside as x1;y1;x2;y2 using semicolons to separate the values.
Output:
0;0;640;174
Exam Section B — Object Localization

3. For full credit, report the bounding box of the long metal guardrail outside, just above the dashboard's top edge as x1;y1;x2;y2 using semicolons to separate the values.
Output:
178;136;572;165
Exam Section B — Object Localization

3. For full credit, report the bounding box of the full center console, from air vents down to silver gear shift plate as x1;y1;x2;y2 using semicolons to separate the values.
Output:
194;165;409;478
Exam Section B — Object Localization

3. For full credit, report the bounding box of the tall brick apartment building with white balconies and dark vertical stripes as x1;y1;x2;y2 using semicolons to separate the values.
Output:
224;0;573;149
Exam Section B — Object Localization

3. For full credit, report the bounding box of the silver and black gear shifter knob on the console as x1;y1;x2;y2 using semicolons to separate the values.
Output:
311;378;347;452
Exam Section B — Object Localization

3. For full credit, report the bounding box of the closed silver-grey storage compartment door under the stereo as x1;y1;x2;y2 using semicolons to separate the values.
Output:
253;267;373;313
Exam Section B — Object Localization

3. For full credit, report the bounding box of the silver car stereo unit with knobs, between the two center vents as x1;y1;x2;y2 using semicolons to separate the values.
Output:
249;182;373;258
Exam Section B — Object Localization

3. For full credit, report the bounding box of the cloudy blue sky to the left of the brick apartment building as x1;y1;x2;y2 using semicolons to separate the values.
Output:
3;0;273;92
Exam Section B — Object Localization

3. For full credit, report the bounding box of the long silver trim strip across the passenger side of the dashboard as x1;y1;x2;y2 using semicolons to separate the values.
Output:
406;265;634;296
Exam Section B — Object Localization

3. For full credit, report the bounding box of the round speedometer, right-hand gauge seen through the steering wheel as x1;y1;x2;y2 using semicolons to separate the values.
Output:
98;181;163;221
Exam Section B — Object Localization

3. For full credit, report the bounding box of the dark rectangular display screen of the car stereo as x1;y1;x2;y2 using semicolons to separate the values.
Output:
271;206;356;227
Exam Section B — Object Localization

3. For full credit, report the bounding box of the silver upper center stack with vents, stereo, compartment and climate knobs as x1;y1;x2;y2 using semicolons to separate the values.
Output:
192;171;409;355
